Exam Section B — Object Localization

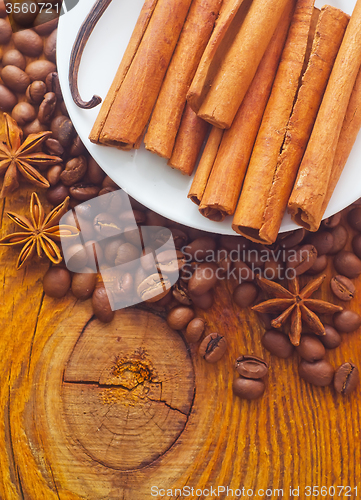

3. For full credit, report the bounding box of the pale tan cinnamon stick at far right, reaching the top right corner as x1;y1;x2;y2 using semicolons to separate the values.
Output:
288;0;361;231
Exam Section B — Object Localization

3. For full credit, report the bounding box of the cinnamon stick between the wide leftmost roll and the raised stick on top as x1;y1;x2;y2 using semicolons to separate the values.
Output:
144;0;222;158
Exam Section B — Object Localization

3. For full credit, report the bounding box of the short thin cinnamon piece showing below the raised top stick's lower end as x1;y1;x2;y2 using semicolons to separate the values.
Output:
188;127;224;205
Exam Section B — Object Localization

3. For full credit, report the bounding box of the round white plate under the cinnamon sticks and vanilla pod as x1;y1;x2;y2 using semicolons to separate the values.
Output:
57;0;361;234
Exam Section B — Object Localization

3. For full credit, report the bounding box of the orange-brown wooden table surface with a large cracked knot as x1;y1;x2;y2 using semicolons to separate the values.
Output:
0;187;361;500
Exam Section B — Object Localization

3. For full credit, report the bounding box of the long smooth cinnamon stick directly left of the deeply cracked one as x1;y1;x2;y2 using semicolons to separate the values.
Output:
199;2;295;221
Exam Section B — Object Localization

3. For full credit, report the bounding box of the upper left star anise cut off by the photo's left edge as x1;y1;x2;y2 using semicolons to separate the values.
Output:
0;113;62;198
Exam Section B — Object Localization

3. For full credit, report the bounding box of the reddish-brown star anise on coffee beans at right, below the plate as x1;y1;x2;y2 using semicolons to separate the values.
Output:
252;274;342;345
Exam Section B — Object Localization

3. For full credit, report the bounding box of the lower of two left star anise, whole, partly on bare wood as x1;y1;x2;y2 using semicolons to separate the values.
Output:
0;193;78;269
